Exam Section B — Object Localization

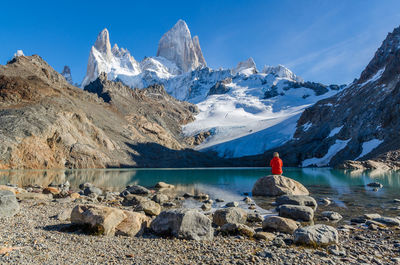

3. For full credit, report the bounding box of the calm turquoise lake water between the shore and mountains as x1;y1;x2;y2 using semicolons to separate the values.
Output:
0;168;400;220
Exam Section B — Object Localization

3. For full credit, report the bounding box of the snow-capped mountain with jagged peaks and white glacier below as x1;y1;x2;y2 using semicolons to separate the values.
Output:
82;20;341;157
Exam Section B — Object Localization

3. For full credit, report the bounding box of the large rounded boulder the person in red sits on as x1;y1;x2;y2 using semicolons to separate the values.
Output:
252;175;309;196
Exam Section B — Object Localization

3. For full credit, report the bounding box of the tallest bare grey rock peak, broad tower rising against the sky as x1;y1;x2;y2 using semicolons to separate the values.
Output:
157;19;206;72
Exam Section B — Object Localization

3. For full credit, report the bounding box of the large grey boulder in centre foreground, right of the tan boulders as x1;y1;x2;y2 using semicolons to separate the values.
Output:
151;209;214;240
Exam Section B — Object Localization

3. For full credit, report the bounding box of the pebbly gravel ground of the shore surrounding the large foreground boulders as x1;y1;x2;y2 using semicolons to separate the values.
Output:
0;178;400;264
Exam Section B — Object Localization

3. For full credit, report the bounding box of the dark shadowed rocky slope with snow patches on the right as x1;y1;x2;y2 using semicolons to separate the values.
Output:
240;27;400;169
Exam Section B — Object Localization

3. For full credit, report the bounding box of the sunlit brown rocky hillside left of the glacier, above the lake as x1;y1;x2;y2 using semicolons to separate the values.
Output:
0;55;227;169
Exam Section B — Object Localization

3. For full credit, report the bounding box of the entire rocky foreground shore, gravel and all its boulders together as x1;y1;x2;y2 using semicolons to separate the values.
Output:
0;176;400;264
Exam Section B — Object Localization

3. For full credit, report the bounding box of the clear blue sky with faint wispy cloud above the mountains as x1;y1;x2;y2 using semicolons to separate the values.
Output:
0;0;400;84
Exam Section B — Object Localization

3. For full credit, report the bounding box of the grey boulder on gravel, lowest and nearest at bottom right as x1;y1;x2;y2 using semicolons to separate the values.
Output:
294;224;339;247
